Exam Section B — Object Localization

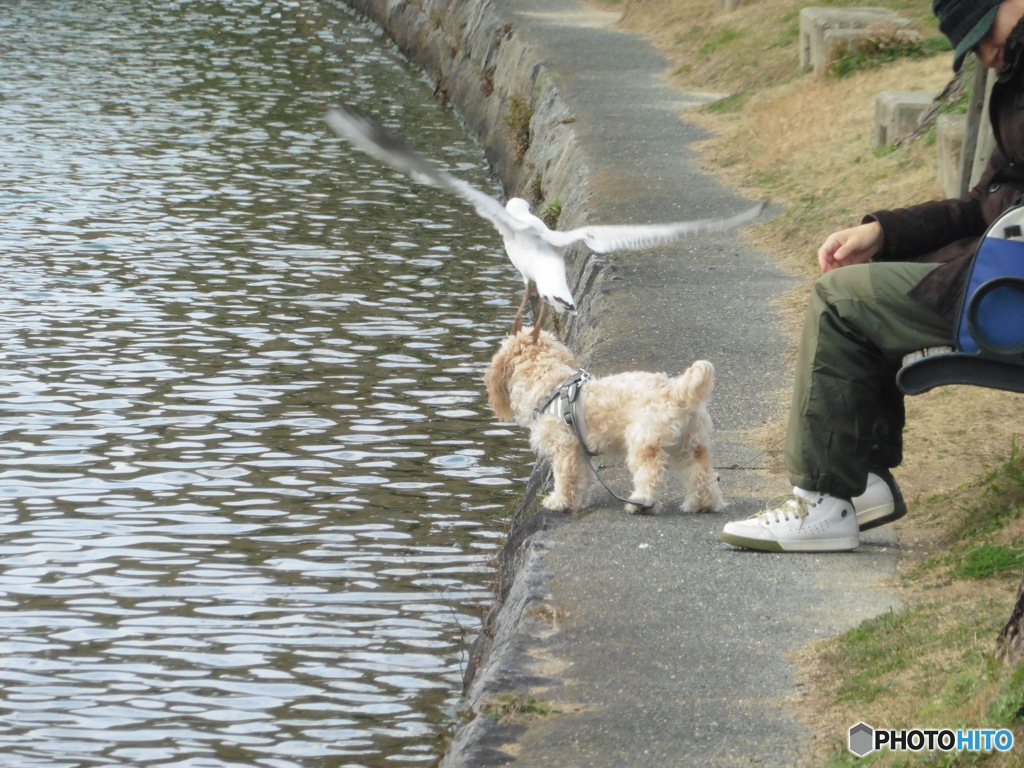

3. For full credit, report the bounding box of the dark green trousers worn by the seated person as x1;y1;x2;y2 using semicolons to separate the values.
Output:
783;261;952;499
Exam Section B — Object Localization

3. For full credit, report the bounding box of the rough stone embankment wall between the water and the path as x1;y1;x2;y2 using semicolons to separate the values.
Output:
345;0;605;768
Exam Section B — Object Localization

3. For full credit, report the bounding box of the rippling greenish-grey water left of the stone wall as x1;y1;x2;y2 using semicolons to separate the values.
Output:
0;0;529;768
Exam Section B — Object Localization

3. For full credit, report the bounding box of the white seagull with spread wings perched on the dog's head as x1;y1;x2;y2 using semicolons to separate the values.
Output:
327;106;764;339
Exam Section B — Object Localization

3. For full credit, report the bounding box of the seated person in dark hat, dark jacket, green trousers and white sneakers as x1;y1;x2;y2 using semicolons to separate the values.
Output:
721;0;1024;552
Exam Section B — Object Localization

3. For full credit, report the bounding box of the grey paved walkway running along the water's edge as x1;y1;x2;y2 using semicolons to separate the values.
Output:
445;0;895;768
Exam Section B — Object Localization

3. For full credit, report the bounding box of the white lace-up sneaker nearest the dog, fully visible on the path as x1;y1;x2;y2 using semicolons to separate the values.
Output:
722;488;860;552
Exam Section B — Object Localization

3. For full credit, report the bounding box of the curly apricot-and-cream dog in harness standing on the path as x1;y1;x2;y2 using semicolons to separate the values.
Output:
483;328;725;513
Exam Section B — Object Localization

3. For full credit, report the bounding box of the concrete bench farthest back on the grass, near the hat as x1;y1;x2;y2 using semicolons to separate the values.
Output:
800;8;918;74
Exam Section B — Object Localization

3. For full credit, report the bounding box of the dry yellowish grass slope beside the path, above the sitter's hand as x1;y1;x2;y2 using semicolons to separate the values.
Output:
589;0;951;275
